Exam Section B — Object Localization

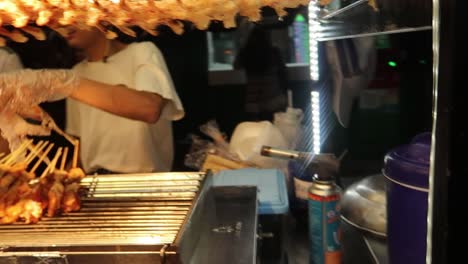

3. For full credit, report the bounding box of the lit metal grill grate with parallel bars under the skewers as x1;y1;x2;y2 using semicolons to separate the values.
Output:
0;173;204;247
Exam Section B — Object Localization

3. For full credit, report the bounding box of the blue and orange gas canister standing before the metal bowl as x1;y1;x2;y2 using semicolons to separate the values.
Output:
308;171;342;264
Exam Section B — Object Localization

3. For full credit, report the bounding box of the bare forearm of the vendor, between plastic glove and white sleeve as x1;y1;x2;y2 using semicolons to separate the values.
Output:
70;79;164;123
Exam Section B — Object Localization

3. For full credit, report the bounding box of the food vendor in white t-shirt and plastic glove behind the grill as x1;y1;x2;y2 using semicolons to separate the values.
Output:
0;27;184;174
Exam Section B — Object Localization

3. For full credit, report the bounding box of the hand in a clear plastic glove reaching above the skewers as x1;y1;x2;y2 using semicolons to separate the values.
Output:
0;69;80;113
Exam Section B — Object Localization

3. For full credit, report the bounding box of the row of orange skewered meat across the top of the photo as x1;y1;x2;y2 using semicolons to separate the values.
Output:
0;0;310;44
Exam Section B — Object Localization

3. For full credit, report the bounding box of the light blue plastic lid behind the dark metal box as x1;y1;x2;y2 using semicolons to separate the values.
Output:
213;169;289;215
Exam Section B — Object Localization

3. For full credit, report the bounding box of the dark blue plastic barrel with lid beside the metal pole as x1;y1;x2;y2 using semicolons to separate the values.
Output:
384;133;431;264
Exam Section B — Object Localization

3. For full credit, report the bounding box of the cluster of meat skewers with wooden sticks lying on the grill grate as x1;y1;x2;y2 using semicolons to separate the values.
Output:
0;140;85;224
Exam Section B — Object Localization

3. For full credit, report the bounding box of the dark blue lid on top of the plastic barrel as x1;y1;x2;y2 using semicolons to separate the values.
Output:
384;133;431;189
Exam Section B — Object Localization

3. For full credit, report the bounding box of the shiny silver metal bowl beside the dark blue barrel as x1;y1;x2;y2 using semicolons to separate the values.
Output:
341;174;387;237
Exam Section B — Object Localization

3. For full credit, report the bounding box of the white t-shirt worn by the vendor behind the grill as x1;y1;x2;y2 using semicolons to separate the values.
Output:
66;42;184;173
